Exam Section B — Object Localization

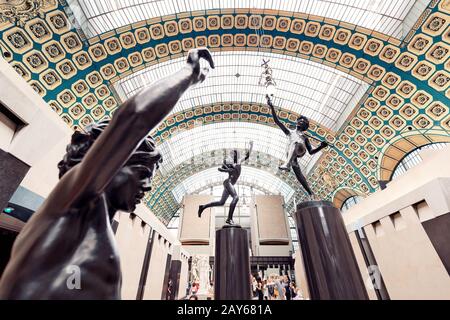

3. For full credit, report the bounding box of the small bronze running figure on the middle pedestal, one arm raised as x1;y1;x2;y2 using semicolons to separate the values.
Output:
198;141;253;225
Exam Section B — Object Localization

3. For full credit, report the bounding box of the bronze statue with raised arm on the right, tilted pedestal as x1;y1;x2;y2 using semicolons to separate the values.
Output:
266;95;328;198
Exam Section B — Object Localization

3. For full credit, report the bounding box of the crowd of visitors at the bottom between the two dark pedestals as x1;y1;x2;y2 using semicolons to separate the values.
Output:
252;274;304;300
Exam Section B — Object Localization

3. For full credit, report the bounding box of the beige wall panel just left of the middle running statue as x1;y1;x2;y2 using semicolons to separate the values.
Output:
179;195;213;244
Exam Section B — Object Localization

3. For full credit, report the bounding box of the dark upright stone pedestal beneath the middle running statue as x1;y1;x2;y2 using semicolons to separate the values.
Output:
214;226;251;300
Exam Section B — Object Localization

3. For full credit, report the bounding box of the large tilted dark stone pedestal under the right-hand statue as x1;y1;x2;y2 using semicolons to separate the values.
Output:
296;201;368;300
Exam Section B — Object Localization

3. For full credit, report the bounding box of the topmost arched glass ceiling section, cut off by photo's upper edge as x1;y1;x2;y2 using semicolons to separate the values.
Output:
68;0;422;39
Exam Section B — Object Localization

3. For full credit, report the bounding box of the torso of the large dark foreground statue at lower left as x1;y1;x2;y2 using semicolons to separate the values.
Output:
0;196;121;299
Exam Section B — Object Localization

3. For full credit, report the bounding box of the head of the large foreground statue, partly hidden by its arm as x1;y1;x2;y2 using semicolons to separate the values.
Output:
58;120;162;212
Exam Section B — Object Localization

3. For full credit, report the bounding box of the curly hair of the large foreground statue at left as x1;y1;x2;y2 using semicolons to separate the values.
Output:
58;120;162;179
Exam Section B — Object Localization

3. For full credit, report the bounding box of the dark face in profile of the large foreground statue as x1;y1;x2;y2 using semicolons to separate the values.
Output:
106;162;155;212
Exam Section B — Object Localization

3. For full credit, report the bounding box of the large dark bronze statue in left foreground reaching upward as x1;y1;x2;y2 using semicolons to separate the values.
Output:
0;48;214;300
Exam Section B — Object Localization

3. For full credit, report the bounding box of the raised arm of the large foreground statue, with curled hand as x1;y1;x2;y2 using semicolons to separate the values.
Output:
53;48;214;209
